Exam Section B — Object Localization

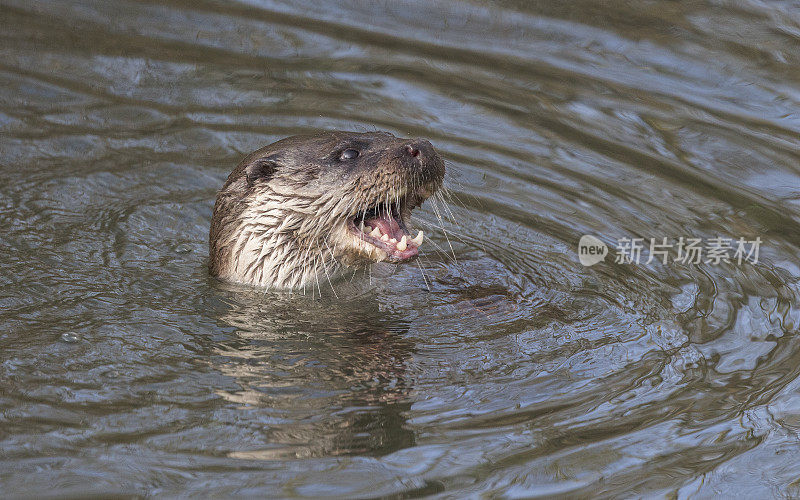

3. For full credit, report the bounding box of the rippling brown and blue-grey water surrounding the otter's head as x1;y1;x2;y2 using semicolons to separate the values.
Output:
0;0;800;498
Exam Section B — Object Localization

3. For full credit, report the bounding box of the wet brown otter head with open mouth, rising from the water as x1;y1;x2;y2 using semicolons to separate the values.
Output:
209;132;445;289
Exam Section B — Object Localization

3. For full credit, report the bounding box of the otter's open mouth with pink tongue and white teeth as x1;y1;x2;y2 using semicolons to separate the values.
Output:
349;201;423;262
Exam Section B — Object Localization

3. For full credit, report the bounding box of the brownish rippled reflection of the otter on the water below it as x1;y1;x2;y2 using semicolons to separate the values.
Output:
206;289;414;459
